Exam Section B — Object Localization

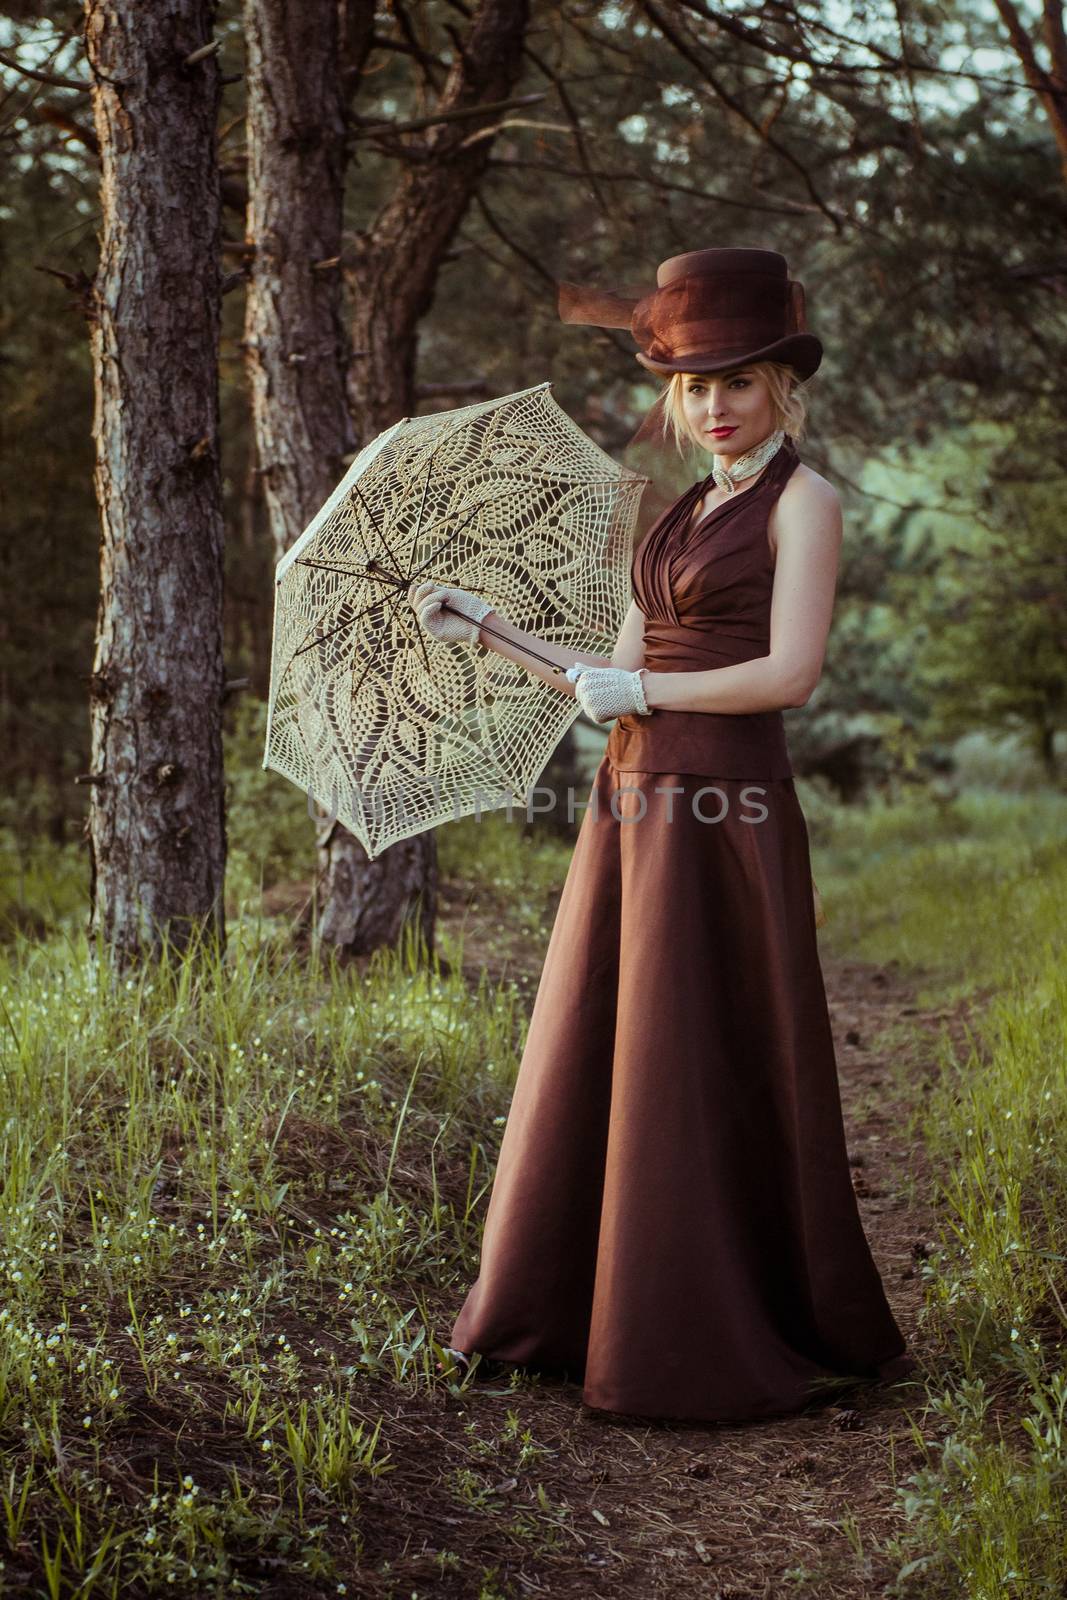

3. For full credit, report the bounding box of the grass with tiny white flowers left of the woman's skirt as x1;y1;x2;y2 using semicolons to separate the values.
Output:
0;896;543;1597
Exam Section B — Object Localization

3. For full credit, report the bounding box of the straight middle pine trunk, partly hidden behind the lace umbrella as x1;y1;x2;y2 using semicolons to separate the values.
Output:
245;0;415;954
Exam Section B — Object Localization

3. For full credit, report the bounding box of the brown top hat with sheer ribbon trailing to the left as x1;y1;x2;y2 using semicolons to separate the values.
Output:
558;250;822;379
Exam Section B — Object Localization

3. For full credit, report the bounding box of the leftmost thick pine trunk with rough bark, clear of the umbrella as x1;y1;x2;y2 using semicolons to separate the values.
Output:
85;0;226;965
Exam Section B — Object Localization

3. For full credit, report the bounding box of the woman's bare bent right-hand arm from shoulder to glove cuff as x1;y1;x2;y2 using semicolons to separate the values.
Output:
643;472;843;712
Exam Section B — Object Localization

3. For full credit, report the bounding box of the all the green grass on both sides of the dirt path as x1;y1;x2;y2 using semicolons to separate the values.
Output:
0;752;1067;1600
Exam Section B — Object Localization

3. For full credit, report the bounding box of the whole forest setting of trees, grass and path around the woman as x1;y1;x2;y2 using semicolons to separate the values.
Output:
0;0;1067;1600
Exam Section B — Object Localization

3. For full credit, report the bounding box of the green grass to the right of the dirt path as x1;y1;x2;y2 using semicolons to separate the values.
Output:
816;780;1067;1600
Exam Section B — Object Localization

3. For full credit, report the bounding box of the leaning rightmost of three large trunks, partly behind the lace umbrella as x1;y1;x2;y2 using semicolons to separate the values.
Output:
318;0;530;954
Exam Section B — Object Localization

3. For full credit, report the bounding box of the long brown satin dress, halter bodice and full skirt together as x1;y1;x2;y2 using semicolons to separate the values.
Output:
450;438;913;1421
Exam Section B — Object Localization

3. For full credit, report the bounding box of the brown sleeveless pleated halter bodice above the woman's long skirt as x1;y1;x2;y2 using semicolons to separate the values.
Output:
606;437;800;779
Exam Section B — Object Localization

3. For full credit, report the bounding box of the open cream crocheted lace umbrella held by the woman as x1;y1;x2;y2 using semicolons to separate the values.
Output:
262;382;646;858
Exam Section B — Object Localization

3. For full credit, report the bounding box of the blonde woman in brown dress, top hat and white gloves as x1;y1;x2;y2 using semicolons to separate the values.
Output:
404;250;915;1421
